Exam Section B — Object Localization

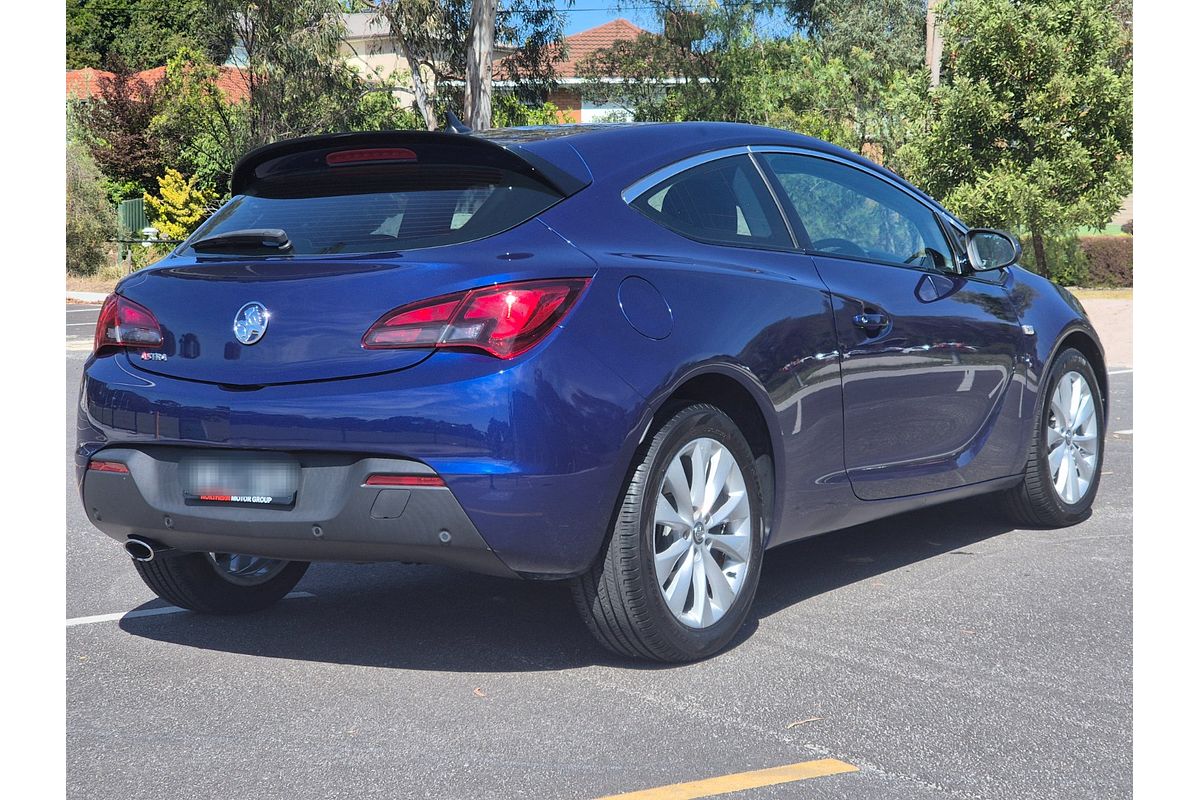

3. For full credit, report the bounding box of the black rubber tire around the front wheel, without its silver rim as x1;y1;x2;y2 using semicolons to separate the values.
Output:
1001;348;1106;528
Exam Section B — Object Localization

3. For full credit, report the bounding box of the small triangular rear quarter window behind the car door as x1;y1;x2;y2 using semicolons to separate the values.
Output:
630;156;792;247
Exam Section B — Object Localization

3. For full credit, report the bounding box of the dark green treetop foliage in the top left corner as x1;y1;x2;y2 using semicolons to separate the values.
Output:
66;0;208;71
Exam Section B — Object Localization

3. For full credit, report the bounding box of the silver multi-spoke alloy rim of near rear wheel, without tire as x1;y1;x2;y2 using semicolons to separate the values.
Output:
653;438;754;628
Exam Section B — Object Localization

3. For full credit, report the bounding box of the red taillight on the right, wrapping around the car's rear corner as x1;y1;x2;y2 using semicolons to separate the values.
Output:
362;278;588;359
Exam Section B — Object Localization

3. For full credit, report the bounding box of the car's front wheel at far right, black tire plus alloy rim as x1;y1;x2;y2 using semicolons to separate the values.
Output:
1004;349;1105;528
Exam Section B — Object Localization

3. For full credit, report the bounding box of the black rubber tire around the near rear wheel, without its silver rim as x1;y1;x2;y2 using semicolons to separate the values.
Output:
571;404;764;662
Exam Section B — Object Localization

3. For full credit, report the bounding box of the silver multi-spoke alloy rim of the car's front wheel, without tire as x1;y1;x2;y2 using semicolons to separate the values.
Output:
1046;372;1099;505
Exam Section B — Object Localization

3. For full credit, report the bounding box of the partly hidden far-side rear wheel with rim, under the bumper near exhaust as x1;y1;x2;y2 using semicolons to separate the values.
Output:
133;552;308;614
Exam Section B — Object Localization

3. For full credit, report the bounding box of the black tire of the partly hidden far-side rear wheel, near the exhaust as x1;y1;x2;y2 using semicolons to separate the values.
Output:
133;552;308;614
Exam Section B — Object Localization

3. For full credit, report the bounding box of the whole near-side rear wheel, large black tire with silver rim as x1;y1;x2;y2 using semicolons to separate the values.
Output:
571;404;764;662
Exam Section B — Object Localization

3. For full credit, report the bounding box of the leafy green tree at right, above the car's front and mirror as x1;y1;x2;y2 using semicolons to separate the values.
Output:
910;0;1133;273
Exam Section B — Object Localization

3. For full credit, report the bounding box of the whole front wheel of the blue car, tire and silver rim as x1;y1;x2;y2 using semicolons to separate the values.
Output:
1002;348;1105;528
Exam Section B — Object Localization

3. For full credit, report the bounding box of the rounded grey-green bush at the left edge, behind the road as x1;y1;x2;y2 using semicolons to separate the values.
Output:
66;142;116;275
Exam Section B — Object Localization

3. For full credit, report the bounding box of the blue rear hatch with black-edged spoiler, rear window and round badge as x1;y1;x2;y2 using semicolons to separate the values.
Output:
119;132;590;386
